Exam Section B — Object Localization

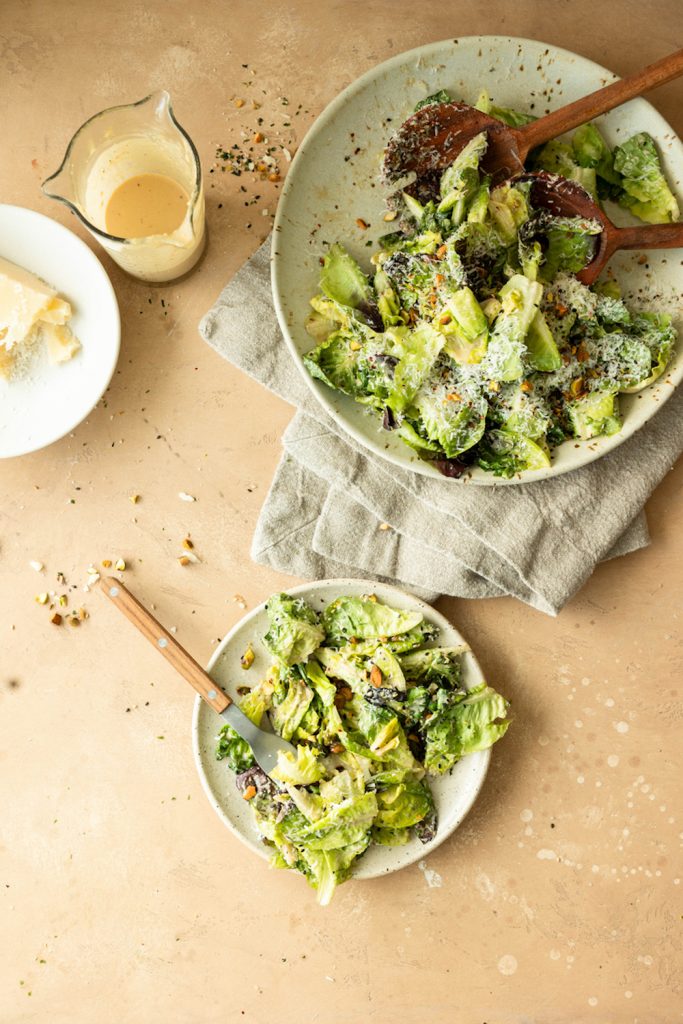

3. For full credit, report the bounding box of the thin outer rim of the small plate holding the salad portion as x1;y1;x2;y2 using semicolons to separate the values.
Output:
191;577;492;881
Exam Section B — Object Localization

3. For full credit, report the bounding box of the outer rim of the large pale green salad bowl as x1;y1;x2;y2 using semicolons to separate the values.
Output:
270;35;683;487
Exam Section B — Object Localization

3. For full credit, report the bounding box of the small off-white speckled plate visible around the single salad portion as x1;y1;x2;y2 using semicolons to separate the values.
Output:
193;580;490;879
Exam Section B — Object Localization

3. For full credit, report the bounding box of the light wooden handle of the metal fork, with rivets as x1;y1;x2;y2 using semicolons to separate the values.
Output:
99;577;231;714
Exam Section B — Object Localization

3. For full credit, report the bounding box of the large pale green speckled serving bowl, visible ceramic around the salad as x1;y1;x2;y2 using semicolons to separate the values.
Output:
272;36;683;486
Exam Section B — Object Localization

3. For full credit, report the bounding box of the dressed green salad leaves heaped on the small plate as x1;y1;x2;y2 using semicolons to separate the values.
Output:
216;594;509;904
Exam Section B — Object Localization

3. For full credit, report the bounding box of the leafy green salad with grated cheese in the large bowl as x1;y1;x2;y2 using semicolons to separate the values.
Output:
304;86;679;477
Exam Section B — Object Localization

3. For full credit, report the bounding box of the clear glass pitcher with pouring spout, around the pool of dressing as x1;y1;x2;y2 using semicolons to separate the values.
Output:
42;91;205;282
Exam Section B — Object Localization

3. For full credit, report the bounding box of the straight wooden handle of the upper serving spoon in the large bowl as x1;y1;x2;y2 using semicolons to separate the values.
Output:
515;50;683;161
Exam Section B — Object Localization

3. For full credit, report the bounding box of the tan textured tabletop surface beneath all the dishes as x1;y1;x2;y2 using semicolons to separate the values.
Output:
0;0;683;1024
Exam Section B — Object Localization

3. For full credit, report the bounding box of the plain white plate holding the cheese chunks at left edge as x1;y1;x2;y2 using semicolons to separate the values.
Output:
0;205;121;459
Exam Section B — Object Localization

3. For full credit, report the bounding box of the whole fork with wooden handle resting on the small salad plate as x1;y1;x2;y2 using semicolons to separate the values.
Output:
99;577;296;775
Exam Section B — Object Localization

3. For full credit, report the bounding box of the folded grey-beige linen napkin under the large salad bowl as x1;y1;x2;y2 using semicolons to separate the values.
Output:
200;240;683;614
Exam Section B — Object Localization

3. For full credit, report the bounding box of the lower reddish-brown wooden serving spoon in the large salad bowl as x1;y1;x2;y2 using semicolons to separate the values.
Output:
515;171;683;285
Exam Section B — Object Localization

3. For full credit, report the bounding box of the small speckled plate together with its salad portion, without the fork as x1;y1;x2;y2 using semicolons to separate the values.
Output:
195;581;510;904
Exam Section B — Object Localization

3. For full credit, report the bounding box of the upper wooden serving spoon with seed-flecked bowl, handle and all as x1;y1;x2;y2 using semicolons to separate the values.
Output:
383;49;683;187
